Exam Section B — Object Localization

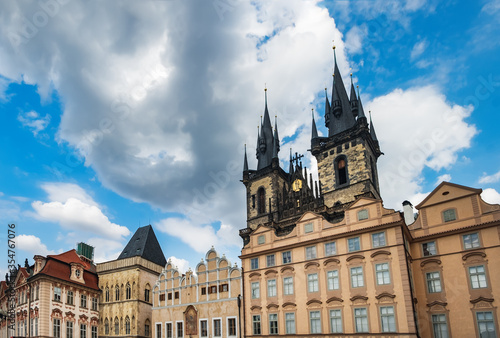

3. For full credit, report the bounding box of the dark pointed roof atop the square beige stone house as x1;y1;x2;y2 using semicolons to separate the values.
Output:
118;225;167;266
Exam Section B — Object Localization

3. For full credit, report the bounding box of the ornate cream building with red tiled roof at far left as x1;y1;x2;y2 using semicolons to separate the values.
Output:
0;243;100;338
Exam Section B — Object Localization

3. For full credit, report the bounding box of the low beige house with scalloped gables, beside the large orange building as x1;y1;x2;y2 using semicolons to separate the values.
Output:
153;247;243;338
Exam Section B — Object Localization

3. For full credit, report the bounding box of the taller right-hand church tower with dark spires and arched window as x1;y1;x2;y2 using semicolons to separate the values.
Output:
311;48;382;208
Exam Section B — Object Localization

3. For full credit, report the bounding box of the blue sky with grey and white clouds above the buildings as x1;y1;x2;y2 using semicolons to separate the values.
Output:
0;0;500;276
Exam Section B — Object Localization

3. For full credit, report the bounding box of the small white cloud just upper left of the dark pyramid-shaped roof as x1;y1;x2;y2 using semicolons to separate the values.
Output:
31;183;130;240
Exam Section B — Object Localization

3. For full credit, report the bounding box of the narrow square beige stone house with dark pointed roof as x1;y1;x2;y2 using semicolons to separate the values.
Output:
97;225;166;337
